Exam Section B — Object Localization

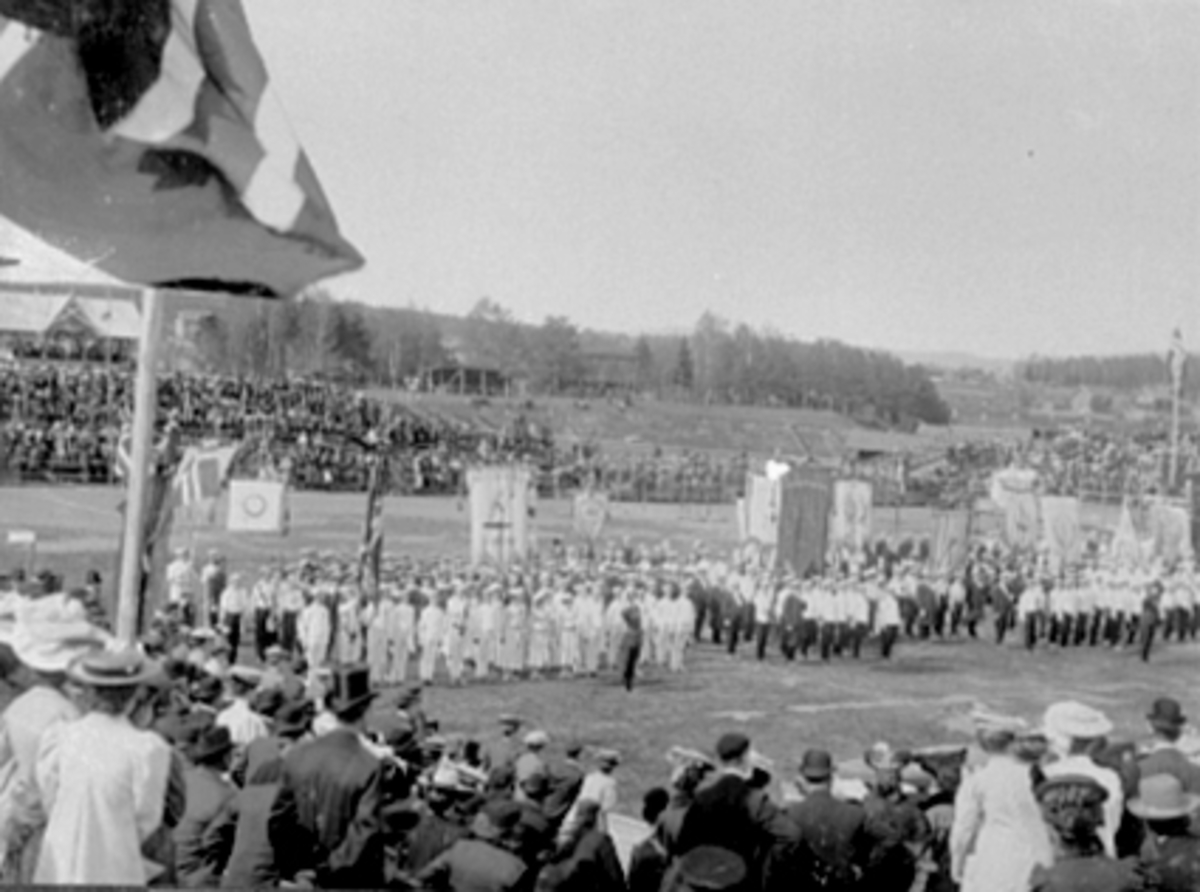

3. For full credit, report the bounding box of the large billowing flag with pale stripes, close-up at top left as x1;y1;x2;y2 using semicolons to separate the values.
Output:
0;0;362;297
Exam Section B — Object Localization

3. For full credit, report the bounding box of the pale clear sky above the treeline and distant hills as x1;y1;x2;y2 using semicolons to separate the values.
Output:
245;0;1200;359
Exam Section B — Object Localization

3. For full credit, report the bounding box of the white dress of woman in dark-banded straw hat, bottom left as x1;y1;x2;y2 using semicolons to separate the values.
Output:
34;712;170;886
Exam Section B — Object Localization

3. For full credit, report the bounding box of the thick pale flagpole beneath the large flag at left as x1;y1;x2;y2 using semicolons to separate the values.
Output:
116;288;162;643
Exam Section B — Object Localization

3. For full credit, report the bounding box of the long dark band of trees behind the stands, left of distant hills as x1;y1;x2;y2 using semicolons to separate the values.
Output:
175;292;950;426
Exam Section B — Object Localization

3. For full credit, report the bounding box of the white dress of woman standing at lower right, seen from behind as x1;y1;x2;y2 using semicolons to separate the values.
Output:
950;755;1054;892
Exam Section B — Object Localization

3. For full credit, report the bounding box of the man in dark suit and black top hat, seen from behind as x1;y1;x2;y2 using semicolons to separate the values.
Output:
268;666;385;888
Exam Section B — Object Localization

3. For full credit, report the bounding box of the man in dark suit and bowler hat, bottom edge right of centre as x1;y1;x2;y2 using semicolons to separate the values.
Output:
763;749;870;892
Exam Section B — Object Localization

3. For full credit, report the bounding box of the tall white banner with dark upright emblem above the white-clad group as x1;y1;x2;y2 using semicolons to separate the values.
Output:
467;466;533;567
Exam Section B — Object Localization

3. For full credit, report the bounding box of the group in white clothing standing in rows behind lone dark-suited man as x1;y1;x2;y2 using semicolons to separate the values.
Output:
220;567;695;684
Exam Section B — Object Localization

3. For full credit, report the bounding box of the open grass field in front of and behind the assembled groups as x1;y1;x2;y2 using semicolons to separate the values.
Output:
0;487;1185;810
